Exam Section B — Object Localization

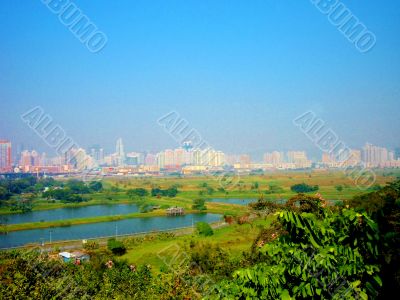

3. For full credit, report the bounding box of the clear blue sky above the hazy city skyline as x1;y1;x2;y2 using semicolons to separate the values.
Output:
0;0;400;159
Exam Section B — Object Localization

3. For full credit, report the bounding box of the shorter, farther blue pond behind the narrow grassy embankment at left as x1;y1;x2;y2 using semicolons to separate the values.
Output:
0;204;138;224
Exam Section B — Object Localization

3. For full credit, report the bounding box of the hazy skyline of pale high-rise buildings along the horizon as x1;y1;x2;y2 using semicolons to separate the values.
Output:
0;139;400;175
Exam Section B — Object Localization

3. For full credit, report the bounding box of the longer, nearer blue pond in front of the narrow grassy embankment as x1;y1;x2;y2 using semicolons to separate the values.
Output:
0;213;221;248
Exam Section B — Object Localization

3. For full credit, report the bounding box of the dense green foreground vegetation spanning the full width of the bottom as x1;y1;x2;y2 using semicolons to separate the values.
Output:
0;177;400;299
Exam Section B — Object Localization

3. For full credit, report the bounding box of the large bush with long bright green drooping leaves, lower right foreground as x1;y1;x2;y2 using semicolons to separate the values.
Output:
214;210;382;299
